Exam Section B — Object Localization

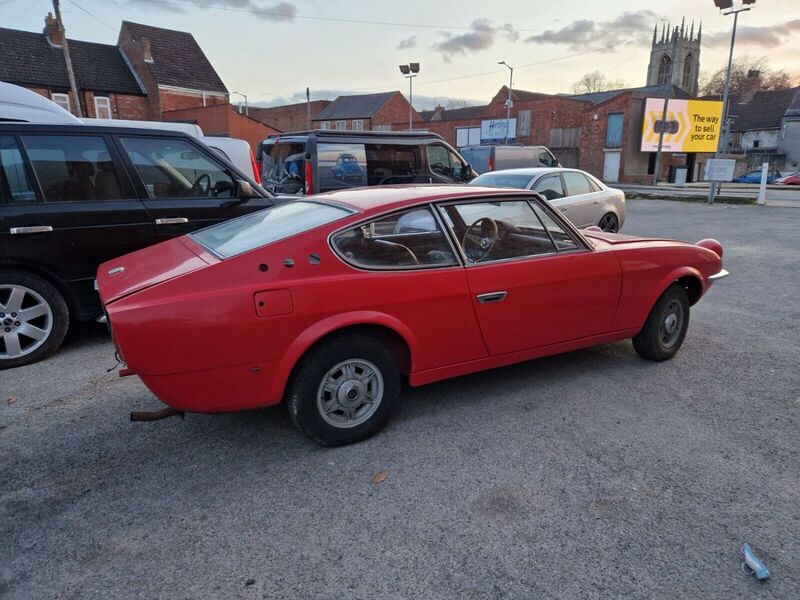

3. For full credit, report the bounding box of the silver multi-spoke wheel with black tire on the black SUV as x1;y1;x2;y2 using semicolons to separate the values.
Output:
0;271;69;370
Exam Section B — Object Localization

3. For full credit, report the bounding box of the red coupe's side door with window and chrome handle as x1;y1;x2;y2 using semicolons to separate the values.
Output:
441;199;622;355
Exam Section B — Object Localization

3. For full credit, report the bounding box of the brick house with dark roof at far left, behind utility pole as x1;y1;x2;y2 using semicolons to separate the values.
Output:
0;14;149;119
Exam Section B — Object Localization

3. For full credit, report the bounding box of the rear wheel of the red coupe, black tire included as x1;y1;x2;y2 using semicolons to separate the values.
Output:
286;334;402;446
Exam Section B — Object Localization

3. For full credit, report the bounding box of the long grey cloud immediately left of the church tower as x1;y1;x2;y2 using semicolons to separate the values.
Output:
525;10;660;51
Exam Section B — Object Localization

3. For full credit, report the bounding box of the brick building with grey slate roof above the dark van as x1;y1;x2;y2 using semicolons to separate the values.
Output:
312;92;424;131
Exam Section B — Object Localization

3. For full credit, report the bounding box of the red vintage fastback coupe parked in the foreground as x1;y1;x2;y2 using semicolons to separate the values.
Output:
97;186;727;445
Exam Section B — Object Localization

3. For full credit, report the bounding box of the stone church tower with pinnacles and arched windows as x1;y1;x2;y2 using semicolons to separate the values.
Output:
647;19;703;96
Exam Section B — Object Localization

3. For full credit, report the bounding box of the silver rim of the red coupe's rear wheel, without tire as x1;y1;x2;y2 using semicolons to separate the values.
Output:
317;358;383;429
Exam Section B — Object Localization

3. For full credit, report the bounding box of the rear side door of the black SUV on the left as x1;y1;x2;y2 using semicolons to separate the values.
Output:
2;130;155;317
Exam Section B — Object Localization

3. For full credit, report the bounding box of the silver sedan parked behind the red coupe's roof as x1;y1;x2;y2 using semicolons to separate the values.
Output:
470;168;625;232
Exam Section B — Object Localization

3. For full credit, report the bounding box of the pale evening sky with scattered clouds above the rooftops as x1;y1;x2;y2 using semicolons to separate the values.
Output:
0;0;800;110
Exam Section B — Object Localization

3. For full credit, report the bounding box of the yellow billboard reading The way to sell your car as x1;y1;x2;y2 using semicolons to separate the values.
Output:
642;98;722;152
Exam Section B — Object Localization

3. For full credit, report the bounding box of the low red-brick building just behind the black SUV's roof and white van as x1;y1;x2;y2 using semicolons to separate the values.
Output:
162;104;280;152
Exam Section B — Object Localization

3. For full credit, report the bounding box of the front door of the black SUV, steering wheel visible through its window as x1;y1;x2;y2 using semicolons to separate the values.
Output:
117;135;273;241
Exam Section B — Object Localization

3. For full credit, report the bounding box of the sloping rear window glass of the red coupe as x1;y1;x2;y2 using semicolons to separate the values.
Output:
189;201;350;258
